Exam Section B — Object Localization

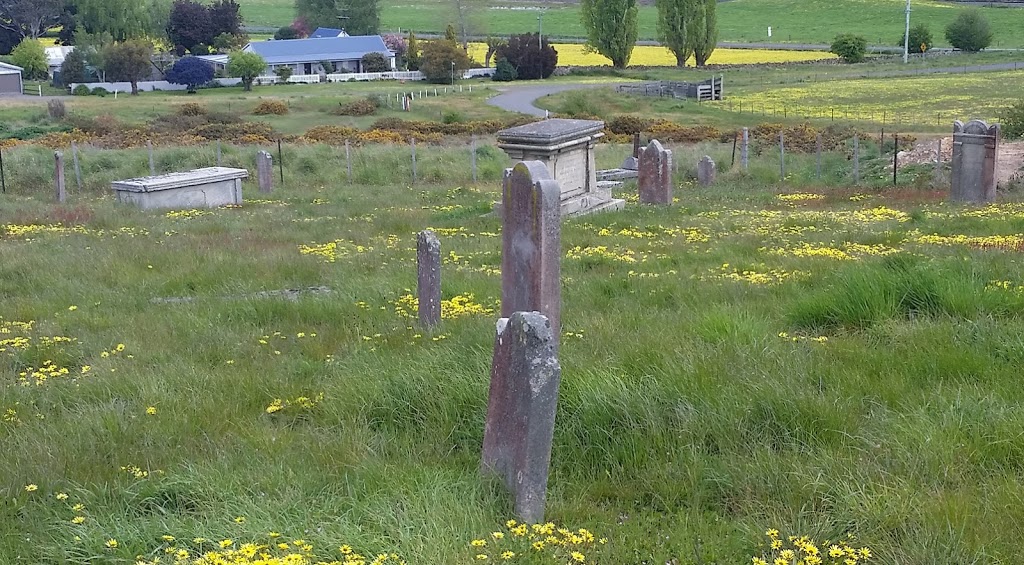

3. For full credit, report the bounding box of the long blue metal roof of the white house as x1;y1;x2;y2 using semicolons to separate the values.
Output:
245;36;394;64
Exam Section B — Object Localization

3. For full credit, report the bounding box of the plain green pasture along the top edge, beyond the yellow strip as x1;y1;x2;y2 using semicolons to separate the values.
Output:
239;0;1024;48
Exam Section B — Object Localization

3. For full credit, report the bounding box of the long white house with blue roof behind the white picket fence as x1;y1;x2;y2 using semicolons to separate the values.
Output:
242;35;394;75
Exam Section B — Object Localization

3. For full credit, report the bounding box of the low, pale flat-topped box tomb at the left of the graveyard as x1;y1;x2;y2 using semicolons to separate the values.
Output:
111;167;249;210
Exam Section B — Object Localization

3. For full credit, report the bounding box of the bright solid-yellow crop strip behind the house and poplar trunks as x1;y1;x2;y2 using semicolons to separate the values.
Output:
469;43;836;67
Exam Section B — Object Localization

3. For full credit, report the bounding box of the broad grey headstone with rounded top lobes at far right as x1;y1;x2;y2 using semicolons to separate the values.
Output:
949;120;999;204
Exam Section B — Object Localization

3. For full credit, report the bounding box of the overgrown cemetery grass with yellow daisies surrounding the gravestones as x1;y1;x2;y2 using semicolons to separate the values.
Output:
6;129;1024;565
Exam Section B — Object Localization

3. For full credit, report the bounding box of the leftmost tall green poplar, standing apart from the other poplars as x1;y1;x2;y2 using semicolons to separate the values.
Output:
580;0;637;69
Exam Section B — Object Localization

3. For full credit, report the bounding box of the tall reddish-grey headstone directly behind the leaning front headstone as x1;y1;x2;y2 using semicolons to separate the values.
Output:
502;161;562;346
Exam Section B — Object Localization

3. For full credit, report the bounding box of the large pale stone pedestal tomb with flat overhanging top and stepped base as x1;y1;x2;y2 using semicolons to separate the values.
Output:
498;119;626;216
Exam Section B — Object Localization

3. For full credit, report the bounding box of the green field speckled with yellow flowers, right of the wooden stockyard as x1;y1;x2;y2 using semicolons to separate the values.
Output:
718;71;1024;124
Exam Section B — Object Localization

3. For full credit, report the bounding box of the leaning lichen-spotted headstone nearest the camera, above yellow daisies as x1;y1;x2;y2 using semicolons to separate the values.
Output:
480;312;561;524
